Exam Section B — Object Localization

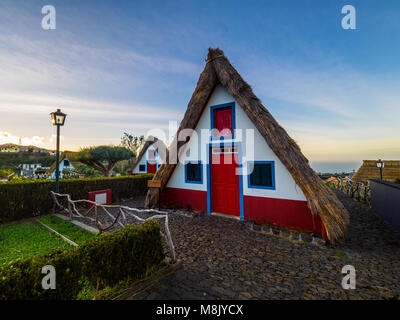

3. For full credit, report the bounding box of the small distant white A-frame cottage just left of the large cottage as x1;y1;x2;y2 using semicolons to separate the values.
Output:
131;137;167;175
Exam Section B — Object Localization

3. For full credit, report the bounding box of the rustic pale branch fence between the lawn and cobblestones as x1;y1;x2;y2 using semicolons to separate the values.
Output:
50;191;176;261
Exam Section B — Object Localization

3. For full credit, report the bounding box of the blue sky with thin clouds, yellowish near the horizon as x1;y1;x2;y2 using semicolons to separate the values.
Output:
0;0;400;169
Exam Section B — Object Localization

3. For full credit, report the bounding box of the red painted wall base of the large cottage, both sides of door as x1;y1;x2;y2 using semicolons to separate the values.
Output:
161;188;327;240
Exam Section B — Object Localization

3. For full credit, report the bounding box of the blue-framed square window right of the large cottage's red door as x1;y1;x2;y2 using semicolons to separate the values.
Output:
247;161;275;190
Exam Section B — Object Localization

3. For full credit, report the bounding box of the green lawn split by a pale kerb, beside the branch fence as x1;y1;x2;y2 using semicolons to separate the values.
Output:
0;216;95;265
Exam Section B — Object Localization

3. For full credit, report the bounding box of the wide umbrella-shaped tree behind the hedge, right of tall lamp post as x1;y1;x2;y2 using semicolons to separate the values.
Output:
76;146;133;177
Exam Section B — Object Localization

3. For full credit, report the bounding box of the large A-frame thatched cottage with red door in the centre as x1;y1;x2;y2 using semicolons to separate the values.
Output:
146;49;348;244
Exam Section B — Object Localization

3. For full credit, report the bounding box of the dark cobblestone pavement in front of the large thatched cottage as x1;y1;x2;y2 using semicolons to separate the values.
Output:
90;191;400;299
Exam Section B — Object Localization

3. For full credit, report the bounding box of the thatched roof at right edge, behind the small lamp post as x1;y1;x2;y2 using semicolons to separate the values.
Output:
351;160;400;183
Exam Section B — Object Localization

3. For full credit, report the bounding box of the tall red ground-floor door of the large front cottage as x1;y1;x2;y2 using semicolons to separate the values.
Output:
211;148;240;216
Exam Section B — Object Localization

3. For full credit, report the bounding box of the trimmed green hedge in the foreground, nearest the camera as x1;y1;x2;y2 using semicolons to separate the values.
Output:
0;221;165;300
